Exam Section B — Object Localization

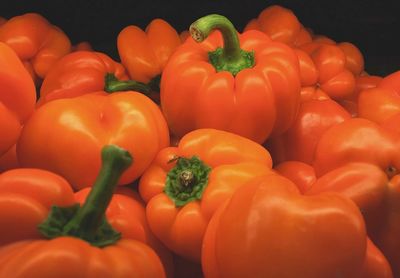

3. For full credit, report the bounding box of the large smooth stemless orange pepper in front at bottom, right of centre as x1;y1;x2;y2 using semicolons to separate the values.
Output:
202;172;367;278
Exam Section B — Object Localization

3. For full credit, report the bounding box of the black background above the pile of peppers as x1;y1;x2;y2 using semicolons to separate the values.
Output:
0;0;400;75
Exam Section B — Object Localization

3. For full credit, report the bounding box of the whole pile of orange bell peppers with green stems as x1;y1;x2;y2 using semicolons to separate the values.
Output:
0;5;400;278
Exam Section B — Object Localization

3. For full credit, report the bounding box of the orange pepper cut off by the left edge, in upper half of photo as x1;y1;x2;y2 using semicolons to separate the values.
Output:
0;42;36;156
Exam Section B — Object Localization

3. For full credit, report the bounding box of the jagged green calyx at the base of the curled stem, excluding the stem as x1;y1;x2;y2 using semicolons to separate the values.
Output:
208;47;254;76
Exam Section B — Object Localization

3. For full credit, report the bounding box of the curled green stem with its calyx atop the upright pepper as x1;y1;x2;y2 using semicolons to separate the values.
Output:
189;14;254;75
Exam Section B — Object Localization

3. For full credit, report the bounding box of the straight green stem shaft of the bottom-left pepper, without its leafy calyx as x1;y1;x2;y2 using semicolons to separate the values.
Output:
64;145;132;239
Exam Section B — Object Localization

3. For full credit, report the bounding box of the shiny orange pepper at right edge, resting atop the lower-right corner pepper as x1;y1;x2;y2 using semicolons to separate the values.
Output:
312;118;400;177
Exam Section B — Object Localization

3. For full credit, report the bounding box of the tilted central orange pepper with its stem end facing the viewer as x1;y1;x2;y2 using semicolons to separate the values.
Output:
139;129;272;262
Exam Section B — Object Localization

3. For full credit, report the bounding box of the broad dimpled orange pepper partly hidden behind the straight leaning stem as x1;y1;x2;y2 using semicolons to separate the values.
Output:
17;91;169;189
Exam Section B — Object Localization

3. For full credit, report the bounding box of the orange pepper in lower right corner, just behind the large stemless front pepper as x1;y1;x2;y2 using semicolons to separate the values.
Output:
305;162;400;277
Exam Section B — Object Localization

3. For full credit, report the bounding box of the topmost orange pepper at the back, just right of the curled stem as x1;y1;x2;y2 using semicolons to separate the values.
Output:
244;5;312;47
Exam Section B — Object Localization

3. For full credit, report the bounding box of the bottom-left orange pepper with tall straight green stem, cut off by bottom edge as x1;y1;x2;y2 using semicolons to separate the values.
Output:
0;145;165;278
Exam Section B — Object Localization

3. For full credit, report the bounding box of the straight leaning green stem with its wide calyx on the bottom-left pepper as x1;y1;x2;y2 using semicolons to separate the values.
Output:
38;145;132;246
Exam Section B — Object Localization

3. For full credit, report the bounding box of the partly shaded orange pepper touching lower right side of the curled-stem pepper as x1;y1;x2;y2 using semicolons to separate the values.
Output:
266;99;351;164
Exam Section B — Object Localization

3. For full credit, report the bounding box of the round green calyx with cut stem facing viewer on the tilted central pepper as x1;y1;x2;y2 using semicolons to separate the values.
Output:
164;156;211;207
